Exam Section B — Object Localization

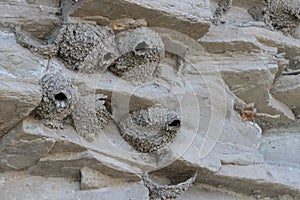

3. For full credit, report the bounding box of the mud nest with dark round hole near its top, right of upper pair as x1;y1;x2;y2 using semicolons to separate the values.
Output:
109;27;164;84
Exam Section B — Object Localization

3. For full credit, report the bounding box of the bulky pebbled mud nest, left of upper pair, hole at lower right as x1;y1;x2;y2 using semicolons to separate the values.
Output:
57;24;115;72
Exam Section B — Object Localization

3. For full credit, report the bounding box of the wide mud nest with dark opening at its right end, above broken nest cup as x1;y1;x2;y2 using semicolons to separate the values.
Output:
119;107;181;153
